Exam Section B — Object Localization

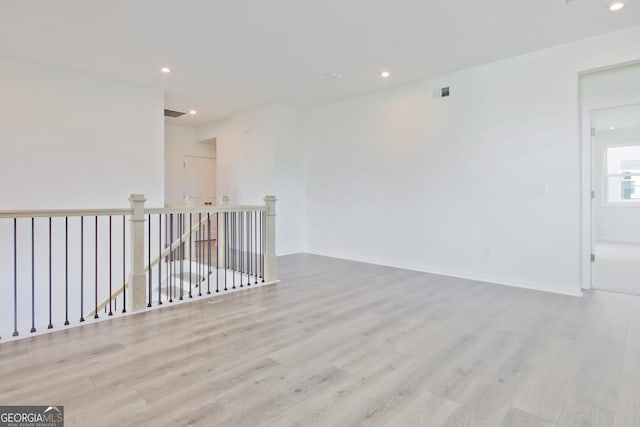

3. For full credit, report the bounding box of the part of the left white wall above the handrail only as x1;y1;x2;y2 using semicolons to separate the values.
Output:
0;58;164;210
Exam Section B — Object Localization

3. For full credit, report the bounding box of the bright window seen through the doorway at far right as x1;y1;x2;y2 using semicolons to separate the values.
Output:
606;145;640;203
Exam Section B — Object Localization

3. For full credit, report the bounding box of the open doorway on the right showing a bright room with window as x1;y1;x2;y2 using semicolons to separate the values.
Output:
591;104;640;295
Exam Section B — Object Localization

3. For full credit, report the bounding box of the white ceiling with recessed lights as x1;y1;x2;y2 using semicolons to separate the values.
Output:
0;0;640;125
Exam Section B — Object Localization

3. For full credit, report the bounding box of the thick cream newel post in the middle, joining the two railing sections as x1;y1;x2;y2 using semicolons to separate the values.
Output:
127;194;147;312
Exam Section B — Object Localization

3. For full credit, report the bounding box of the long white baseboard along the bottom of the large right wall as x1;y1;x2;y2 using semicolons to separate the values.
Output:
307;252;583;297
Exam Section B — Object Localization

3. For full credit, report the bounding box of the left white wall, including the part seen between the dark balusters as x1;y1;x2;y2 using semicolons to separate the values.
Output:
0;58;164;338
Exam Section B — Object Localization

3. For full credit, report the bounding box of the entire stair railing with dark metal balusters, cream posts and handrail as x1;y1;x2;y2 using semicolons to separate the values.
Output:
0;194;277;339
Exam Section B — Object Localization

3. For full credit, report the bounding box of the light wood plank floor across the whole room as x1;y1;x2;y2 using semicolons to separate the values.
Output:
0;255;640;427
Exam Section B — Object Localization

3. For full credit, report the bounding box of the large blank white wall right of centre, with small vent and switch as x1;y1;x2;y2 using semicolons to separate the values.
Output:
304;27;640;295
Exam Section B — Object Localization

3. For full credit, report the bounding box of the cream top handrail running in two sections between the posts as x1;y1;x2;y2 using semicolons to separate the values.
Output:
0;205;267;218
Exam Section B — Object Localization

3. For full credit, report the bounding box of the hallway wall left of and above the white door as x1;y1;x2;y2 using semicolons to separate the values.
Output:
164;123;216;204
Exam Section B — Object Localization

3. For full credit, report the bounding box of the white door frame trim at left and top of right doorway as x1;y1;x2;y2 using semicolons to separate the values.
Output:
580;98;640;289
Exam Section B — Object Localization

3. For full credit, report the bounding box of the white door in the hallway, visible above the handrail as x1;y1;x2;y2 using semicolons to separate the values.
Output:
183;156;216;206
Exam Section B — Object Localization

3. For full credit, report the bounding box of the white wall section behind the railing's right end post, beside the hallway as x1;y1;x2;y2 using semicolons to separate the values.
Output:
196;105;305;255
